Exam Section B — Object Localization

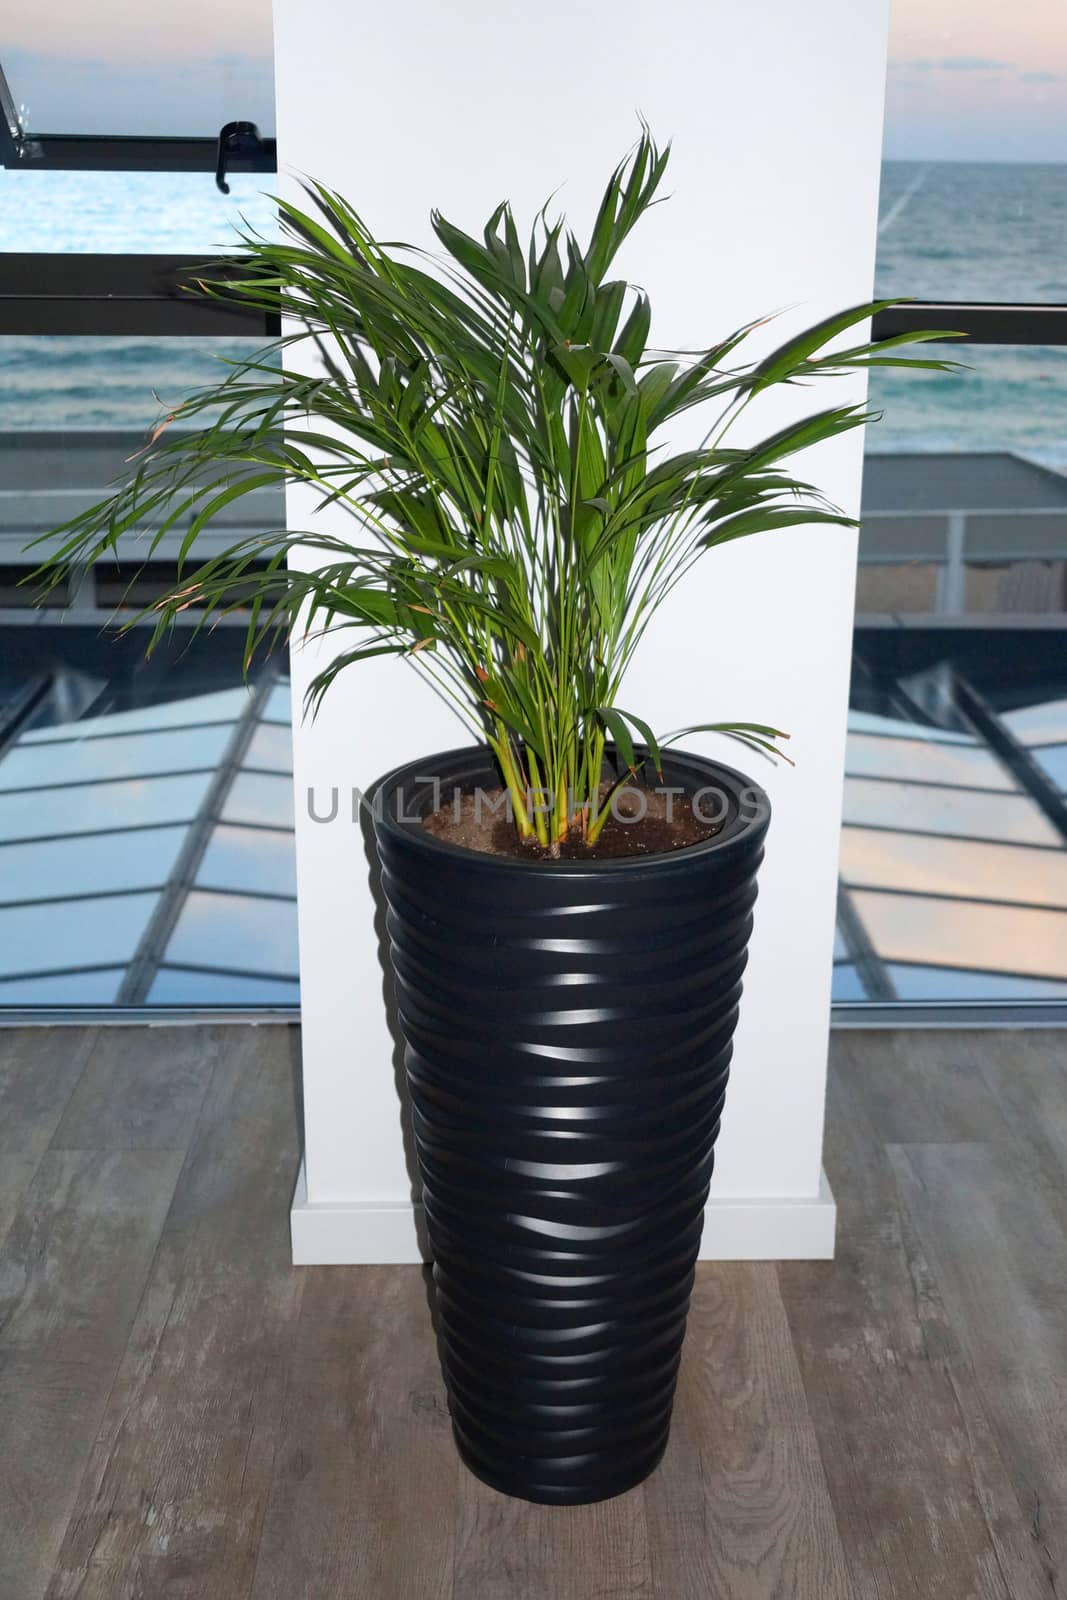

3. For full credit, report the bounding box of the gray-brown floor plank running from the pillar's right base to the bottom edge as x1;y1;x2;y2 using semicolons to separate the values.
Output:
777;1035;1046;1600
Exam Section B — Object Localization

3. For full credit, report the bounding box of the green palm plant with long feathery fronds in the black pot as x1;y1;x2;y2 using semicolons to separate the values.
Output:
33;131;949;854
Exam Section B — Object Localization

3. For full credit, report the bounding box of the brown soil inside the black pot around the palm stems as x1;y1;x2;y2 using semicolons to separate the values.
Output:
422;784;723;861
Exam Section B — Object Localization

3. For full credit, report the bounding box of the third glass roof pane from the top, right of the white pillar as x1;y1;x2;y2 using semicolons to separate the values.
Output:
845;778;1061;845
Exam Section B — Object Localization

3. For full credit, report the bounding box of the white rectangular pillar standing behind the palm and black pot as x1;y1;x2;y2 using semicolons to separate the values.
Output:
283;0;888;1262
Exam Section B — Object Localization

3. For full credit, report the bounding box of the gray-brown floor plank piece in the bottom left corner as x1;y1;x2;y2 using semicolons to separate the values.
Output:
0;1352;114;1600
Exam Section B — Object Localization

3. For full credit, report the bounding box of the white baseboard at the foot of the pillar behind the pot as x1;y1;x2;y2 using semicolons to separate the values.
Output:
290;1162;837;1267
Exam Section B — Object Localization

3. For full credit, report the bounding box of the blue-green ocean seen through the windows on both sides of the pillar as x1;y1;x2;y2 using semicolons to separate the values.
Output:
0;162;1067;472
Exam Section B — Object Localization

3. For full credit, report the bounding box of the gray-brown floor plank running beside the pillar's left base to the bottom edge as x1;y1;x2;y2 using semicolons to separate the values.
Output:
48;1027;304;1600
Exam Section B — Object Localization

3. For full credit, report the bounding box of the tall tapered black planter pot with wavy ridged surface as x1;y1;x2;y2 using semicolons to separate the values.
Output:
371;749;769;1506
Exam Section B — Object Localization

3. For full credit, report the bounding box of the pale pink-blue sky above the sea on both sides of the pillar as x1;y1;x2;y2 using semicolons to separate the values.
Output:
0;0;1067;162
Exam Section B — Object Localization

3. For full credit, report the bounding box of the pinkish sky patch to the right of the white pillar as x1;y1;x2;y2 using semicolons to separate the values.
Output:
885;0;1067;162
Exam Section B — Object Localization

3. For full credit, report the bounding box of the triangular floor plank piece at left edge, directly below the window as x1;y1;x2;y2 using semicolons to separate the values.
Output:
0;1027;98;1242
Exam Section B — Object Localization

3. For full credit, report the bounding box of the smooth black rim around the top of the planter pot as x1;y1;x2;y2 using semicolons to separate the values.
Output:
365;744;771;878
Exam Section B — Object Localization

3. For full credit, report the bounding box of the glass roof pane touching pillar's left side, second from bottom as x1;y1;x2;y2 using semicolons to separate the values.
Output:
165;890;298;978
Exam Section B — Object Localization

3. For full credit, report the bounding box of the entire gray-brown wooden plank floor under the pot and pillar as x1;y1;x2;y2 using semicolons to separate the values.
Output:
0;1026;1067;1600
